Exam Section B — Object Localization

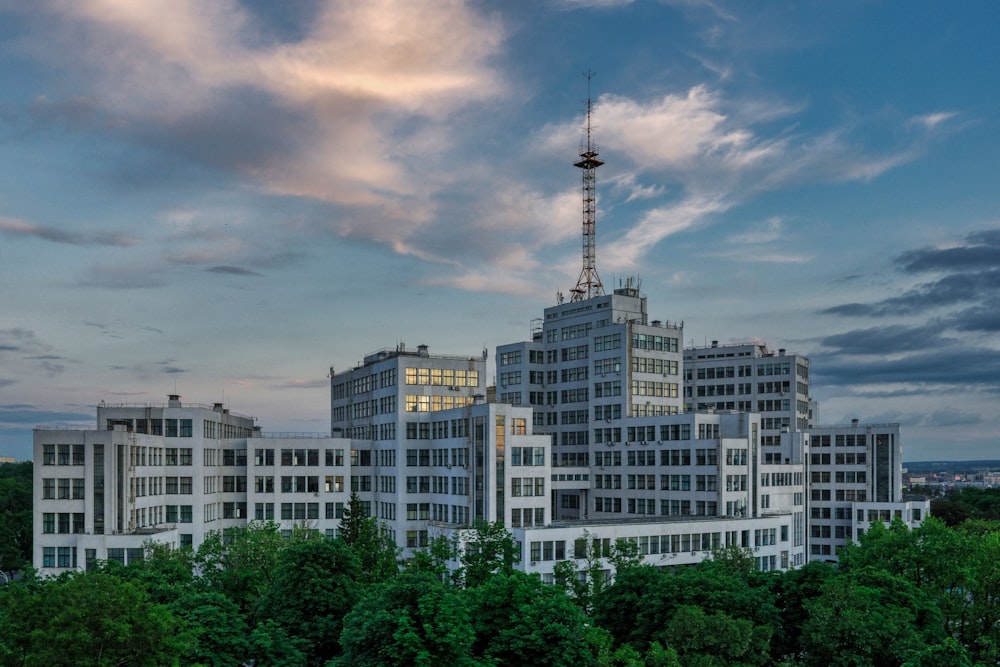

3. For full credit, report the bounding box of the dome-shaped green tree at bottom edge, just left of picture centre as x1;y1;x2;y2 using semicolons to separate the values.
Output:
332;572;475;667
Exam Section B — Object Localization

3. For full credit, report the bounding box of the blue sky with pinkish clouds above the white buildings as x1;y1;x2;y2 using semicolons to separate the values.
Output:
0;0;1000;460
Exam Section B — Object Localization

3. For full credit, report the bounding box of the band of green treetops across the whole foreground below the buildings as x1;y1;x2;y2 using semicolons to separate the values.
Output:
0;517;1000;667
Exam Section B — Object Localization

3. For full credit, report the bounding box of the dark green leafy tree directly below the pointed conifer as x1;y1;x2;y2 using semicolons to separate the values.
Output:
257;539;362;665
